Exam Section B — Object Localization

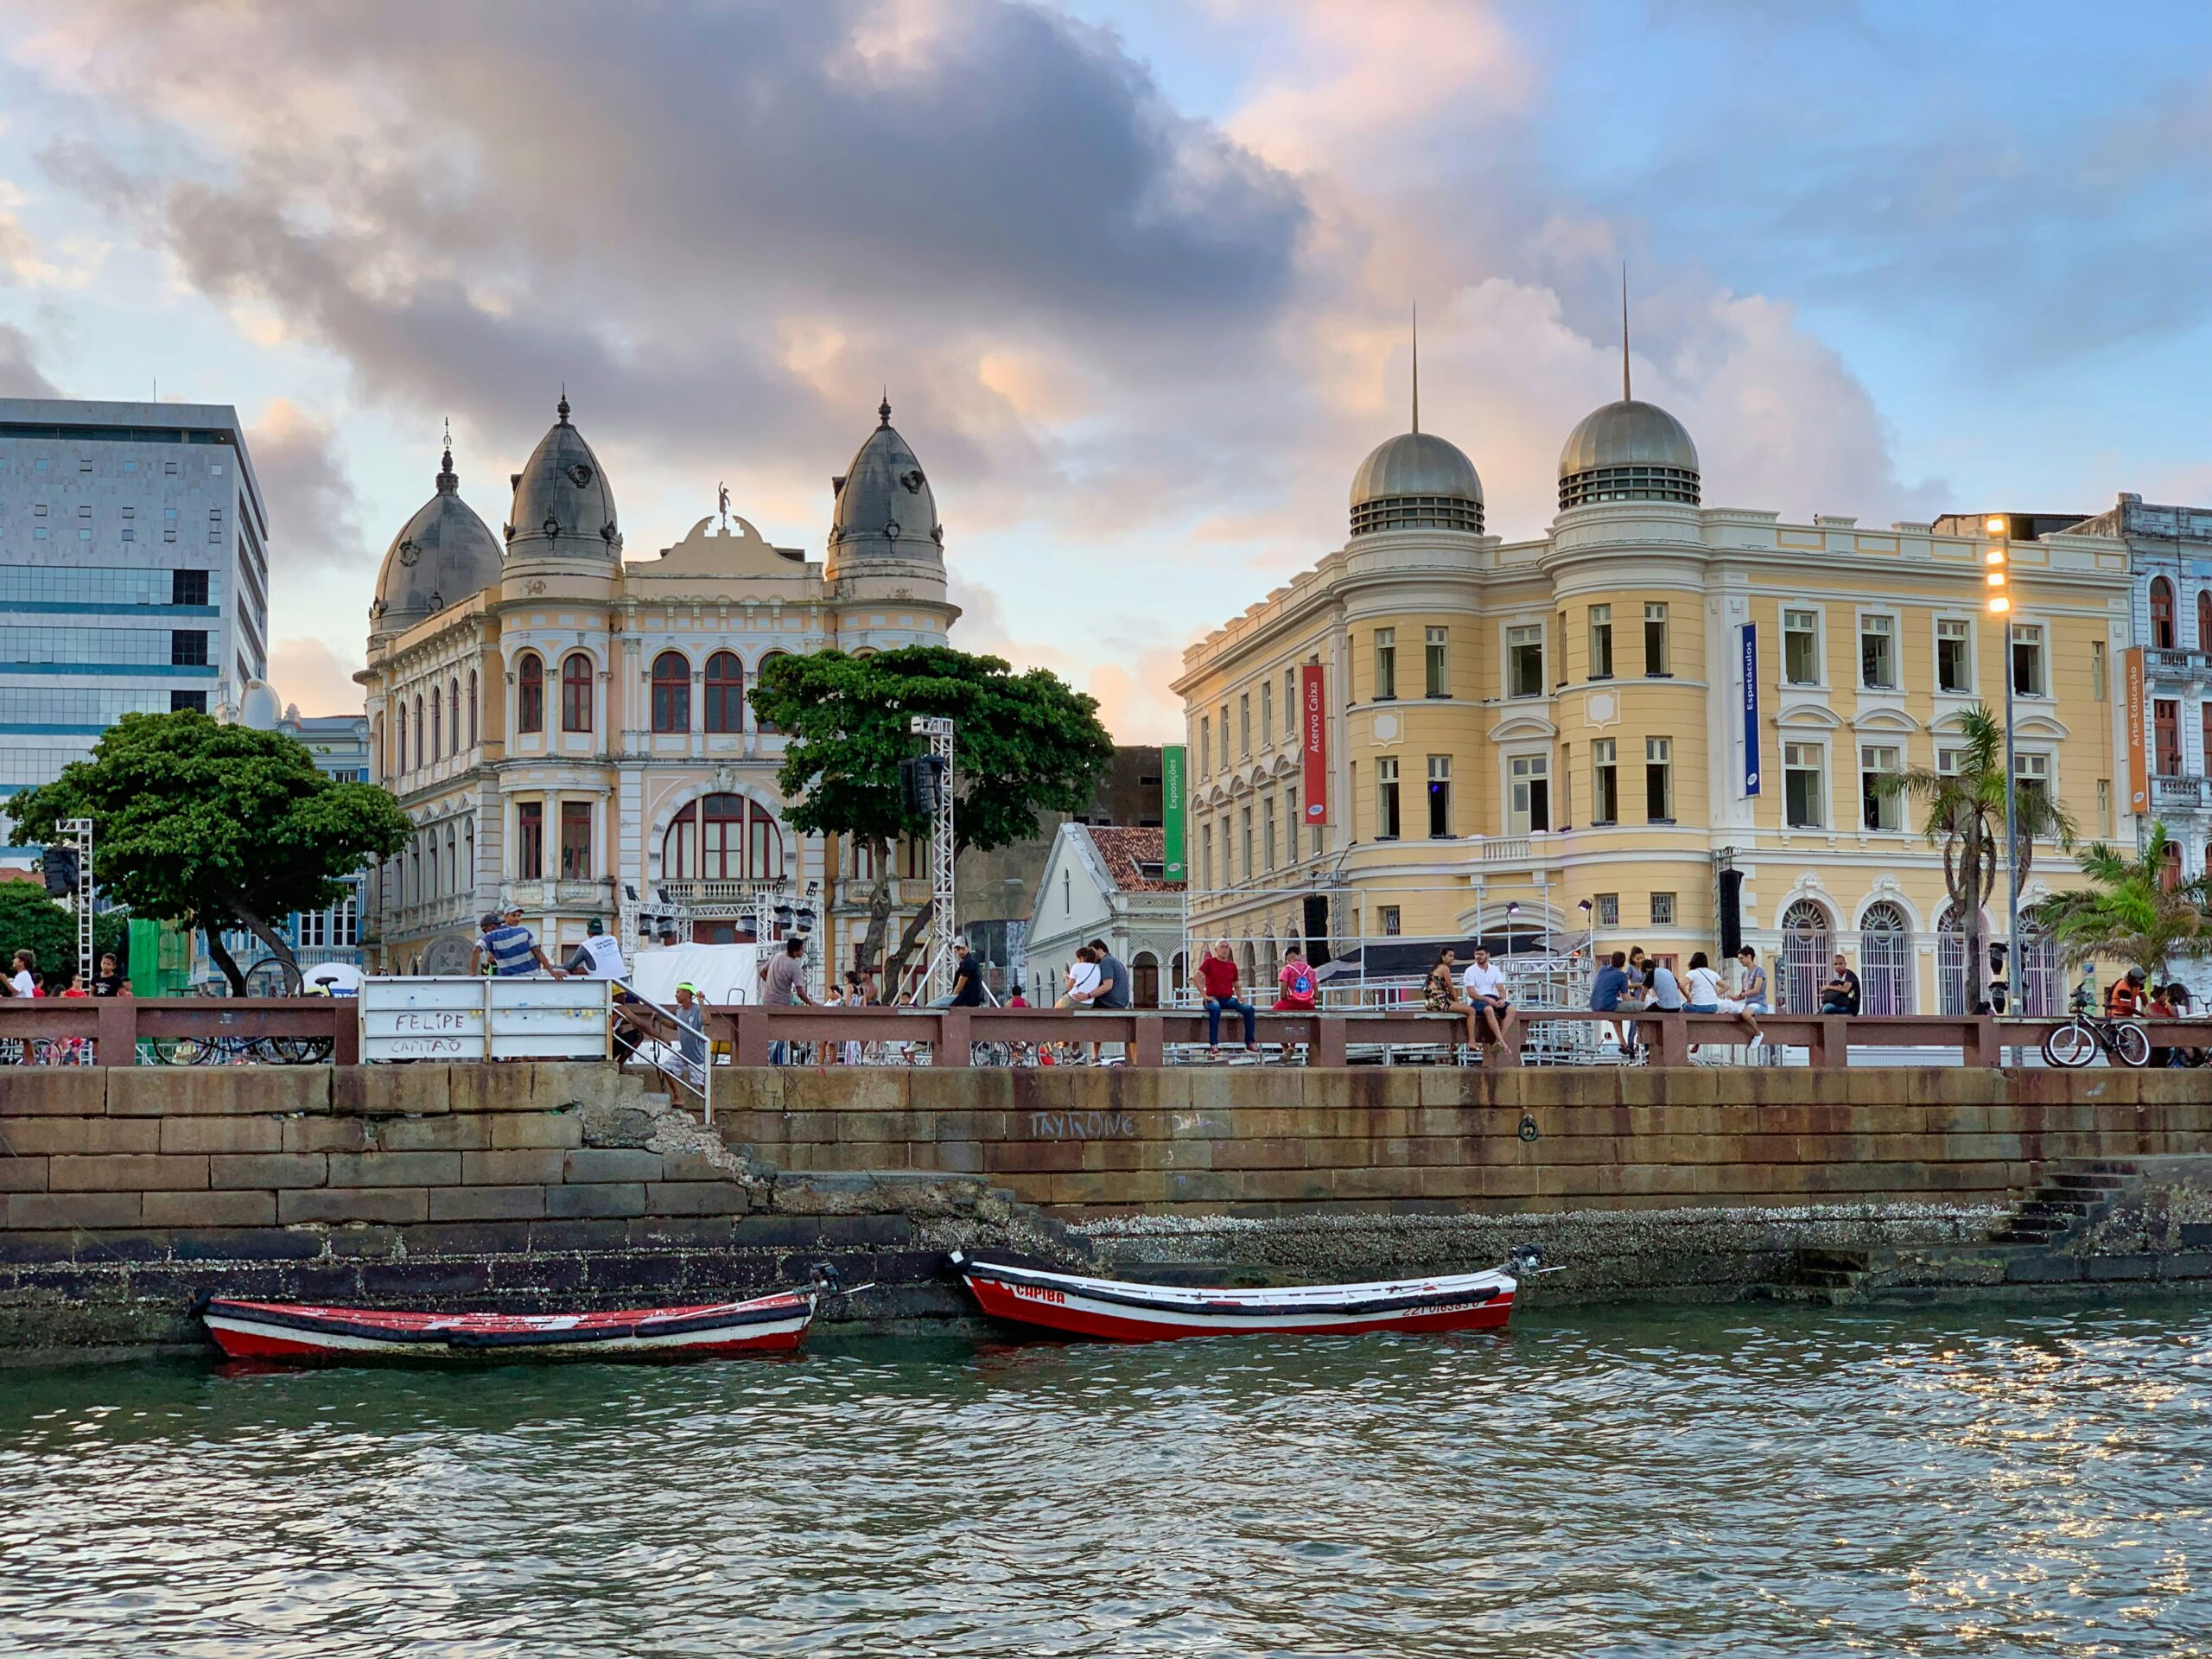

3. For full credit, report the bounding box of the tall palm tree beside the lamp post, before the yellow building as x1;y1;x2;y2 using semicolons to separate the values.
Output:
1873;703;2075;1013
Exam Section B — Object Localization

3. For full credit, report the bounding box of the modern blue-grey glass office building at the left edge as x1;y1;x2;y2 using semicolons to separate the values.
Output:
0;398;270;818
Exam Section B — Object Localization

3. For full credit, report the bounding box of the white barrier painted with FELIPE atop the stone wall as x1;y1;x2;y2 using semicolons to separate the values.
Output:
360;976;613;1062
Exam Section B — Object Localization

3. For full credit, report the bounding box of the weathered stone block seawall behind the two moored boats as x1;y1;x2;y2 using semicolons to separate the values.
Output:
0;1064;2212;1350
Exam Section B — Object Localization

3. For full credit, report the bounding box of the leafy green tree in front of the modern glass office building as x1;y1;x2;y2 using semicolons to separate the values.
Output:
7;710;410;995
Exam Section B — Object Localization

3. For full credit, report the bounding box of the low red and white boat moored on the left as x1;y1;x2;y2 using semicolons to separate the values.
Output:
201;1285;821;1360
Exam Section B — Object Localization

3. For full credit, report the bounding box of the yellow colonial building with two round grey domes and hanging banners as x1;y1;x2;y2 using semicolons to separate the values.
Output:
1177;385;2130;1013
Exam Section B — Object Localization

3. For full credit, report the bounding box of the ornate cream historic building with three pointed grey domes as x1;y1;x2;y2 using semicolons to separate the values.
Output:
359;396;960;971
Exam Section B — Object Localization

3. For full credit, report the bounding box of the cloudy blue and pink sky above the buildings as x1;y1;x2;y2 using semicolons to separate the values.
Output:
0;0;2212;741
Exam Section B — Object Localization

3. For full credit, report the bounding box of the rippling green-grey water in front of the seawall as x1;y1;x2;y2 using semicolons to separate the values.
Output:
0;1300;2212;1659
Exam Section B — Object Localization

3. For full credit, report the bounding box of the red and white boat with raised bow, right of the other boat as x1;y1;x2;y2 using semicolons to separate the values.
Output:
951;1248;1537;1343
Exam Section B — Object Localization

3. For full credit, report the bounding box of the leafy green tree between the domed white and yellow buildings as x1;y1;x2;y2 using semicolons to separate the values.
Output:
752;646;1113;984
